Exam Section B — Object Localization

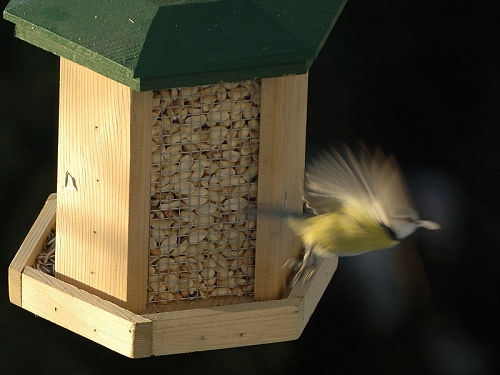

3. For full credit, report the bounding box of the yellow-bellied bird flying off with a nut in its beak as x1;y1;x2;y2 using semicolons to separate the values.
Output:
284;143;440;287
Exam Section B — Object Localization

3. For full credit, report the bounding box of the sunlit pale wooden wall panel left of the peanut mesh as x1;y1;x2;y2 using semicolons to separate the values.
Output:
55;59;152;312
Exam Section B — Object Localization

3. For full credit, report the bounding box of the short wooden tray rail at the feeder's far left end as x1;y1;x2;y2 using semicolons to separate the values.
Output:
9;194;56;306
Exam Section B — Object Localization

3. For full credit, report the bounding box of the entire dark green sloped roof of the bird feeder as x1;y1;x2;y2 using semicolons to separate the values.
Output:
3;0;347;91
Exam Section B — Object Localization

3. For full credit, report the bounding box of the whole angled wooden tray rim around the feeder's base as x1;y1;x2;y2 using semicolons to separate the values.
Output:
9;194;338;358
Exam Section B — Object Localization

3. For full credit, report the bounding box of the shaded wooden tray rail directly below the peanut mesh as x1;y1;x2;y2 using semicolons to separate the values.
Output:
144;298;301;355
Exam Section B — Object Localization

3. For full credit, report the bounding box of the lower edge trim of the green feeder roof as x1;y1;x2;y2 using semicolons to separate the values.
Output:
3;0;347;91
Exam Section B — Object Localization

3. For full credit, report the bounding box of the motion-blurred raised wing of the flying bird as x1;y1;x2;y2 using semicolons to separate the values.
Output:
303;145;418;227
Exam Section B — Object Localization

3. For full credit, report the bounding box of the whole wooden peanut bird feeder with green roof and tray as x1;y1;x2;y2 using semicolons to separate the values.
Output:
4;0;345;357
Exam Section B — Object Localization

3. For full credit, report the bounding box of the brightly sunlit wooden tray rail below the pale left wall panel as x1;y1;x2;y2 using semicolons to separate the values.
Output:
22;267;152;358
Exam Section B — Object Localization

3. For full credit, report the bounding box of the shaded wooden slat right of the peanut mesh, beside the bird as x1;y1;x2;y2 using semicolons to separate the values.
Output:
255;74;308;300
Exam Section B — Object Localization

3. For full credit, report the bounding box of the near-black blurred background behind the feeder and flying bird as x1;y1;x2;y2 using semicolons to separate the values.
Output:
0;0;500;374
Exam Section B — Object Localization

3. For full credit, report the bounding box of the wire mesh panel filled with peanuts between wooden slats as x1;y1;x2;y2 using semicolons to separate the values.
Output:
148;81;260;305
